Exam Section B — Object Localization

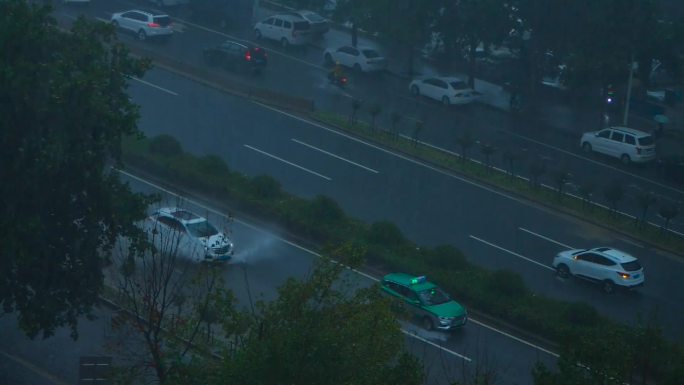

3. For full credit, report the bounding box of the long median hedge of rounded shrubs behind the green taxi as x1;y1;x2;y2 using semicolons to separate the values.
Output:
123;135;684;384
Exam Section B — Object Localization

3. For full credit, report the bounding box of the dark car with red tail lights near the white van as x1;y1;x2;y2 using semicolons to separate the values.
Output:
204;40;268;72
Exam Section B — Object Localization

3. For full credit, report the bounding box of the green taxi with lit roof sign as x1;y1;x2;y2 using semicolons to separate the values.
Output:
381;273;468;330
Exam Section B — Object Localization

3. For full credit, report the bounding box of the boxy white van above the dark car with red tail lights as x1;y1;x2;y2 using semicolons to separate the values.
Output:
254;15;311;48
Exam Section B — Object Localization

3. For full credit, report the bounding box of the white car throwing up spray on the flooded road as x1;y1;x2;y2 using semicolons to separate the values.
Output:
146;207;233;261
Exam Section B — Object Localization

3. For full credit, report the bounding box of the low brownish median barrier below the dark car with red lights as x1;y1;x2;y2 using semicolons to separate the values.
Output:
129;45;315;113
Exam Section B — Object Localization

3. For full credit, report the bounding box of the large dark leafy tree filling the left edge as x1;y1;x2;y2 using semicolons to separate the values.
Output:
0;0;149;337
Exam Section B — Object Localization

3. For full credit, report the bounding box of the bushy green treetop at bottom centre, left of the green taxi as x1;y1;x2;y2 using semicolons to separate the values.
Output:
215;245;423;385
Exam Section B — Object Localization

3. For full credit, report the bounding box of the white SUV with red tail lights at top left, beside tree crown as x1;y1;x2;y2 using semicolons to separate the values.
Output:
111;9;173;40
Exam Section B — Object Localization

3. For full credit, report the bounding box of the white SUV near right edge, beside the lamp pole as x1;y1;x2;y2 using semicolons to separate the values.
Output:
580;127;656;164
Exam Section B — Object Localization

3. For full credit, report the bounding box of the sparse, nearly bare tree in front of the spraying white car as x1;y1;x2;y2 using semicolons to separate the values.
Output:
110;207;240;384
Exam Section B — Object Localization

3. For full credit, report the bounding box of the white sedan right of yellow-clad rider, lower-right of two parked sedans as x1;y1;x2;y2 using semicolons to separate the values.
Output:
409;77;482;105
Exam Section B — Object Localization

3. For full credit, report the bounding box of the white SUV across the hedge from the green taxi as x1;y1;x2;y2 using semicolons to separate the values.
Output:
553;247;644;293
